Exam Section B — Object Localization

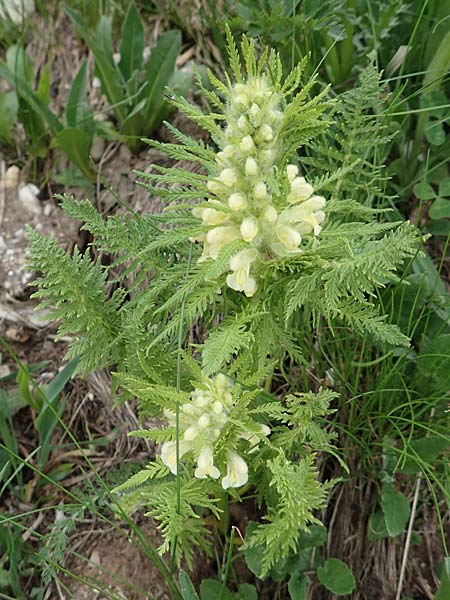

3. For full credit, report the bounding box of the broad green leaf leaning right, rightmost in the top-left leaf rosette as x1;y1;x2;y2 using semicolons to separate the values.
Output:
143;30;181;132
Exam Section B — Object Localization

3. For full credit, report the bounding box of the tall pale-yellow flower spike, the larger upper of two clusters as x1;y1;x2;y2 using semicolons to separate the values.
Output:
193;76;326;296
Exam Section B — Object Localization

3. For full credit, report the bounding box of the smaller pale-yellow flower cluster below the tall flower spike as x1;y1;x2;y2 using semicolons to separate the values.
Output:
161;374;270;489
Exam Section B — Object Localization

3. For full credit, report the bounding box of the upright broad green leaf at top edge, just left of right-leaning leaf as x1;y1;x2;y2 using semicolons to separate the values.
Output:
119;2;144;81
